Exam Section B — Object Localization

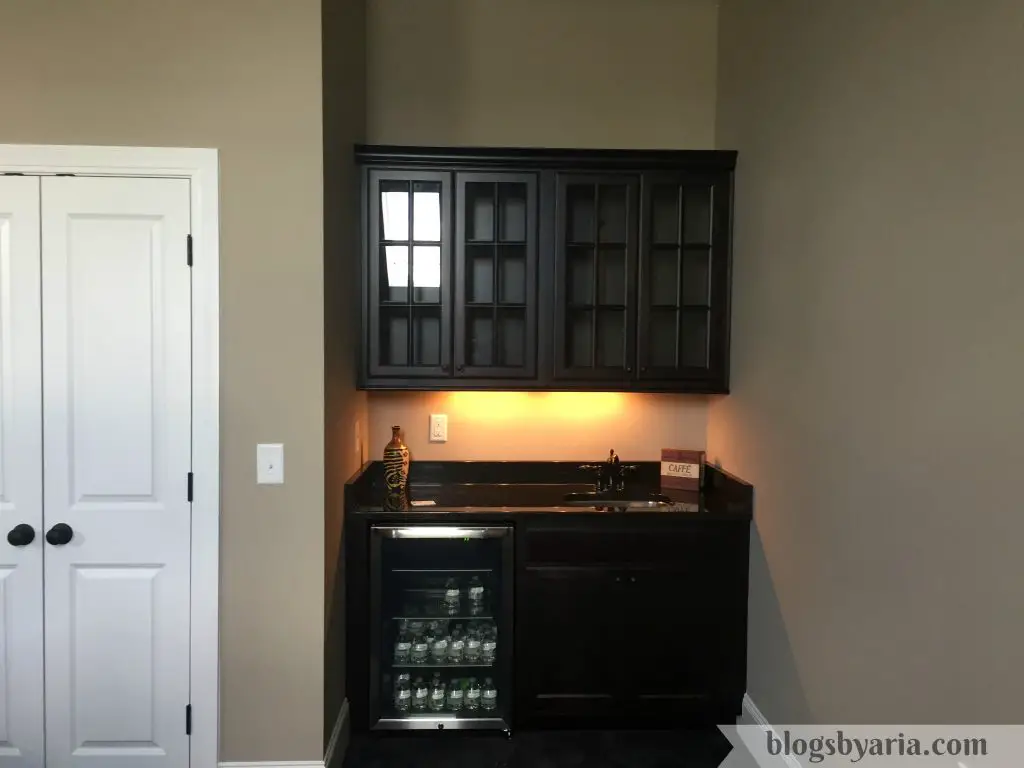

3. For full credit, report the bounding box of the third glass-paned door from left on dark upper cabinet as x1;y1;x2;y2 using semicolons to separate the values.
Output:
554;174;639;382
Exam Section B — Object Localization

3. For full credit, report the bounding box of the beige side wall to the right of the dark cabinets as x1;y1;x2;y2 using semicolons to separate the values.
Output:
709;0;1024;723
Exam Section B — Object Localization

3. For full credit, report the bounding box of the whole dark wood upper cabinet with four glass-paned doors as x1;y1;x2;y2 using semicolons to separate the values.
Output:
355;145;736;392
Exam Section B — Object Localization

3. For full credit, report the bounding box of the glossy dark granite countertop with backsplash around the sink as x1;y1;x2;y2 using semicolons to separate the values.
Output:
345;462;753;520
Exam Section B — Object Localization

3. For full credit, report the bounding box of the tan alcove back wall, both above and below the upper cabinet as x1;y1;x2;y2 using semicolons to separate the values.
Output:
367;0;718;460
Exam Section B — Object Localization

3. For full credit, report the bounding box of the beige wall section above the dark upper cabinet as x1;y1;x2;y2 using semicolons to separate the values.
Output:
367;0;718;148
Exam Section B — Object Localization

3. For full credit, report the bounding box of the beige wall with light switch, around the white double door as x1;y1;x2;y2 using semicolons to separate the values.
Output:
0;0;324;761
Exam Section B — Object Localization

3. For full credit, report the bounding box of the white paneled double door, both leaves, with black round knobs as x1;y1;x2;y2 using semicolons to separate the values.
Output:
0;176;191;768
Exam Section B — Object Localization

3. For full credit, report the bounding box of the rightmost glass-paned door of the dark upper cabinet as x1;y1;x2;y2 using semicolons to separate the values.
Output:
638;173;731;386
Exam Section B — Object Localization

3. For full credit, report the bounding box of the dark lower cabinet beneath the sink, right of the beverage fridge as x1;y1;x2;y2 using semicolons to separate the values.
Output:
516;521;748;727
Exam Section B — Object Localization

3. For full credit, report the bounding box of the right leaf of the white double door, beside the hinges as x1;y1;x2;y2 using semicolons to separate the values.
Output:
41;177;191;768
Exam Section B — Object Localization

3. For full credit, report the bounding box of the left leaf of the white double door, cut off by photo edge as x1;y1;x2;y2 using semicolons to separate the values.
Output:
0;176;43;768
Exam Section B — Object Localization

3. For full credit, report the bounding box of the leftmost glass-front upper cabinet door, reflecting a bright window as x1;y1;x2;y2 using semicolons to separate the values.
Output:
366;170;452;377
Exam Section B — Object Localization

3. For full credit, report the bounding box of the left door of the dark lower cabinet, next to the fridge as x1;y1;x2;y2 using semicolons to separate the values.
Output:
516;565;622;719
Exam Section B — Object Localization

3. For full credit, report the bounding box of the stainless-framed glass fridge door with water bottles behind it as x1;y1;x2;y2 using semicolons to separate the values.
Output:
370;525;512;730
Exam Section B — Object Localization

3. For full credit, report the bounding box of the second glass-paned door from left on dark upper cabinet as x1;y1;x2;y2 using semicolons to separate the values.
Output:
455;173;538;379
